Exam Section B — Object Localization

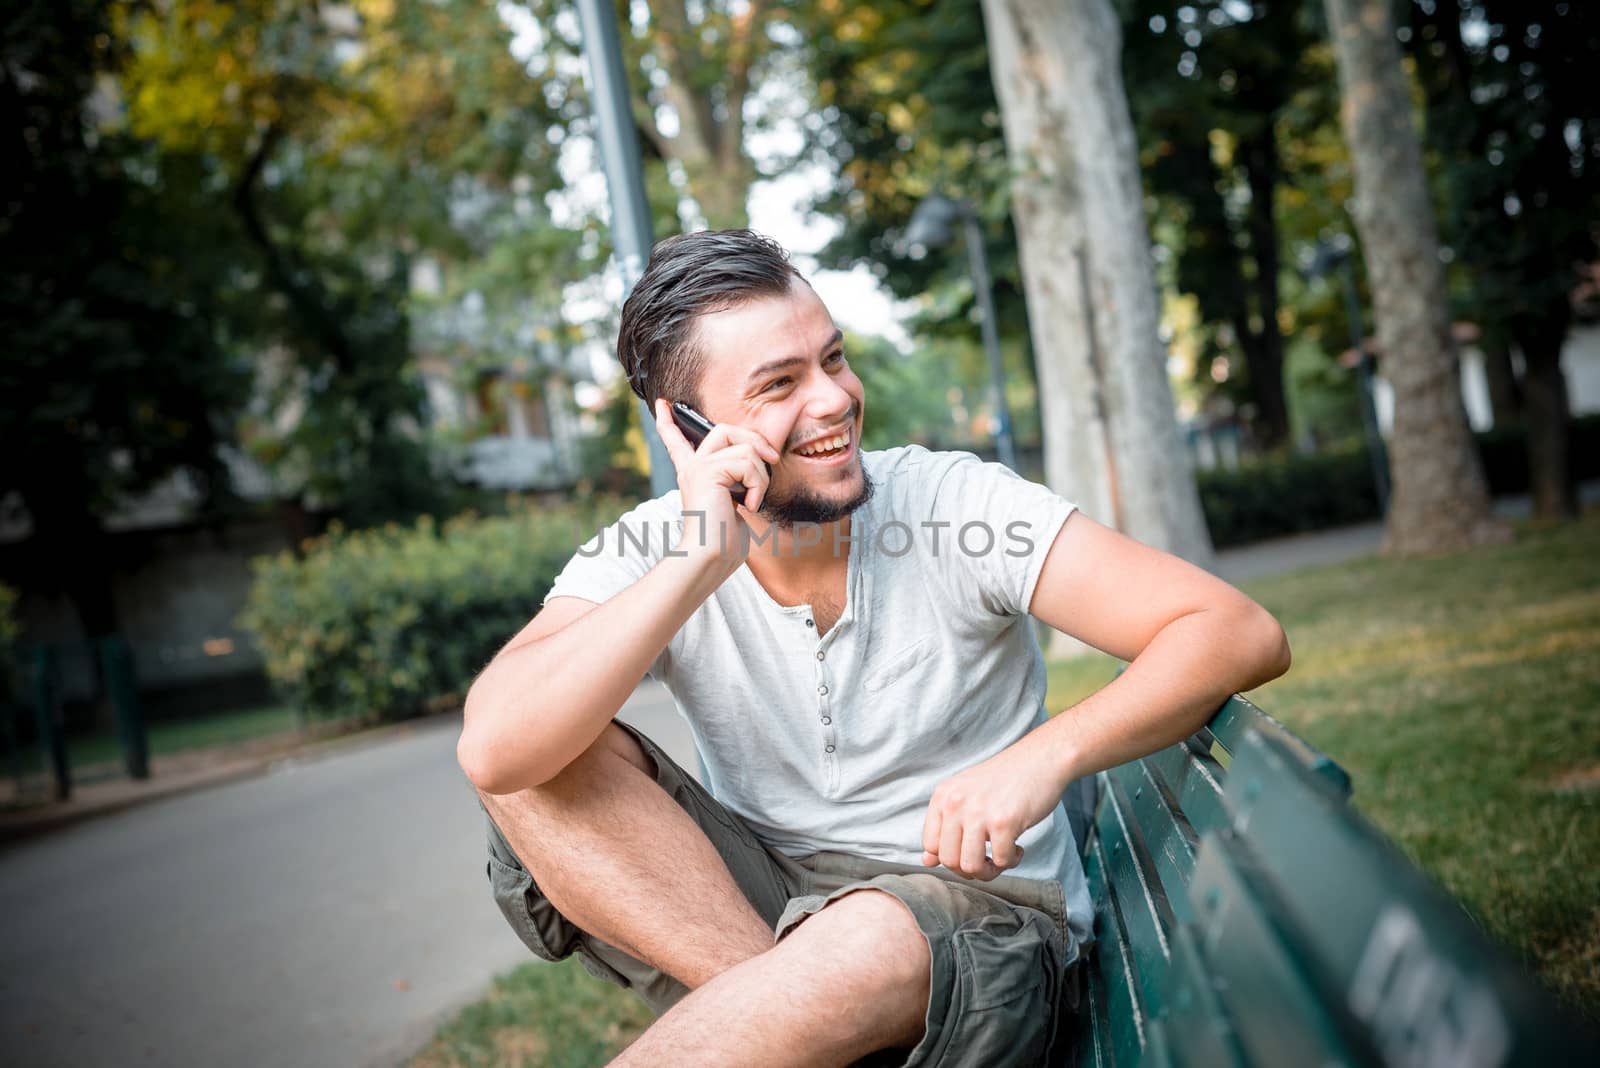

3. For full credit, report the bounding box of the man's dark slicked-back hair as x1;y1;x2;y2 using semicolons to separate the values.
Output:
616;230;800;408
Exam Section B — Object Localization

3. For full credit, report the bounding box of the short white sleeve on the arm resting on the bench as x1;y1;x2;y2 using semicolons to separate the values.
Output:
928;452;1077;617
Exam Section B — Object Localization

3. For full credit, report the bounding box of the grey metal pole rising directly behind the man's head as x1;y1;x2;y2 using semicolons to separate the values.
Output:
578;0;678;497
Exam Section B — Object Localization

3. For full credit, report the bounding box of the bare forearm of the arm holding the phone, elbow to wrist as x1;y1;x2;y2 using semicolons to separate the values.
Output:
456;555;728;793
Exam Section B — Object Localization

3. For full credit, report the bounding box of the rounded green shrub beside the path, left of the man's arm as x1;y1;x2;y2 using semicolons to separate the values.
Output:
240;499;626;719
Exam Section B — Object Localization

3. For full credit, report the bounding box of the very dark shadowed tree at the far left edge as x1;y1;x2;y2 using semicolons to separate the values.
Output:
0;0;248;638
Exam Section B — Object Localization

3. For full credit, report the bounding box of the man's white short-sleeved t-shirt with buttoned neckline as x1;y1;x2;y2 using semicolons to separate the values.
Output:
547;446;1091;940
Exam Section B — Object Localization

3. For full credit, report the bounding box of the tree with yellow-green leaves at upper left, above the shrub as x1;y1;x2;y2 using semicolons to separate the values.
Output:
118;0;586;524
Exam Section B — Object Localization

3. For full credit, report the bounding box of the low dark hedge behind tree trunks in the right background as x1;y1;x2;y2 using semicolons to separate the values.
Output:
1195;416;1600;548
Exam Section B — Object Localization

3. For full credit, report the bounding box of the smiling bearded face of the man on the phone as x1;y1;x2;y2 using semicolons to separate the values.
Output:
694;280;872;526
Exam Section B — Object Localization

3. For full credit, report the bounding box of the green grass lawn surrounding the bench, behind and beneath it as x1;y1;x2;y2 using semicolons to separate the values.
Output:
413;510;1600;1068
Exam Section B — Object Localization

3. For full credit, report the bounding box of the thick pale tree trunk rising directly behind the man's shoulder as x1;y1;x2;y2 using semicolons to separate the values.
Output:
984;0;1211;566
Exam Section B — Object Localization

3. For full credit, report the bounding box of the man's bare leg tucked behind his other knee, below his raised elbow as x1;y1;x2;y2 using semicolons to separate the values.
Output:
482;724;773;990
